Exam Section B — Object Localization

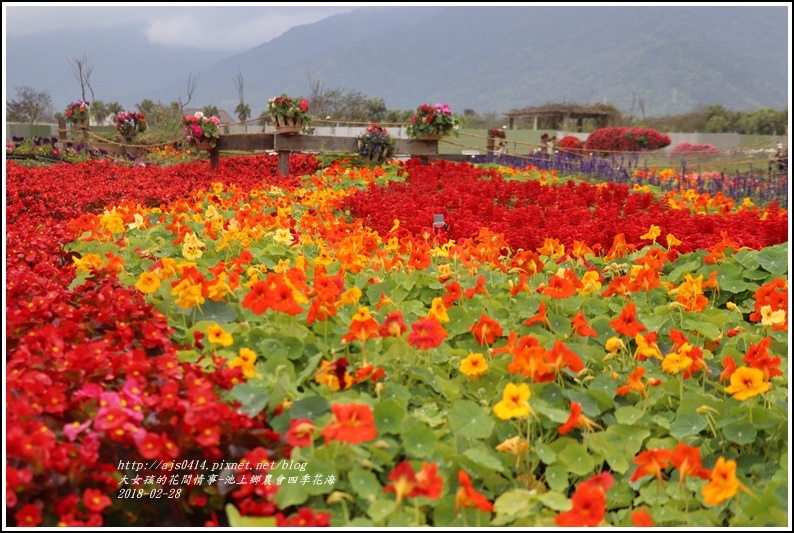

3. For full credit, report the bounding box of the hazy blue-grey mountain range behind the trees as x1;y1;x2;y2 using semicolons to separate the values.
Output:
6;5;791;116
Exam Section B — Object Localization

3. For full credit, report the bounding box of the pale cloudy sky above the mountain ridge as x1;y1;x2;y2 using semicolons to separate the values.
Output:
3;2;358;52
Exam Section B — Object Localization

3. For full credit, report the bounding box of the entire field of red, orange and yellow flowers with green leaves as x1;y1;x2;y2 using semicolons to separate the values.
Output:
5;155;790;527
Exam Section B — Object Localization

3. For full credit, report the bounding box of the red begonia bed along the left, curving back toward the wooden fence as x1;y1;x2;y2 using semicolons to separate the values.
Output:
6;156;317;526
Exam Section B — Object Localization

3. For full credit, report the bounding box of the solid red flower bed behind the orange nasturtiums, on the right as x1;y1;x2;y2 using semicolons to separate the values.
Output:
344;160;788;253
